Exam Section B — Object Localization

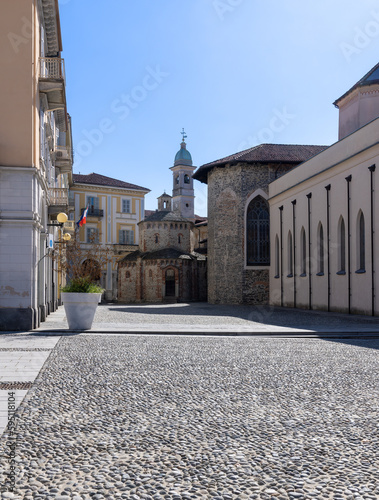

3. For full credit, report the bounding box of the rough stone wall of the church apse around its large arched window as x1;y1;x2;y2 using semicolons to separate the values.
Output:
208;163;293;304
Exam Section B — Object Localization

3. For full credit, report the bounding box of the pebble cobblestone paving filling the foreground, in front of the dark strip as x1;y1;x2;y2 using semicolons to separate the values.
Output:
0;334;379;500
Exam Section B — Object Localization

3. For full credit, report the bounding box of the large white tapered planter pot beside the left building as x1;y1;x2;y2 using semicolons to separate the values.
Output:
61;292;101;330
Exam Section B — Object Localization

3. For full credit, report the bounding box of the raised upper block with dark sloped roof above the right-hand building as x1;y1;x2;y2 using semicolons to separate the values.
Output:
334;63;379;140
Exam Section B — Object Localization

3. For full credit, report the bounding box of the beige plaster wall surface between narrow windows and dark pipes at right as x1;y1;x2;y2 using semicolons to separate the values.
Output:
270;120;379;314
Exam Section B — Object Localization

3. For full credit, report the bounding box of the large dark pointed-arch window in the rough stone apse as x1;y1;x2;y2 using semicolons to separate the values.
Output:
246;196;270;266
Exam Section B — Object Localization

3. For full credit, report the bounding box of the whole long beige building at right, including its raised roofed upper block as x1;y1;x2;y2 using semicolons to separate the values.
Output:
269;61;379;315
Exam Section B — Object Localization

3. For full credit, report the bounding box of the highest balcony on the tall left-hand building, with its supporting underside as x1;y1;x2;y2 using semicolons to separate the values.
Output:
39;57;67;130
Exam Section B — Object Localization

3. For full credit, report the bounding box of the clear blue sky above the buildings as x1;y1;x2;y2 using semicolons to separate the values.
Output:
59;0;379;215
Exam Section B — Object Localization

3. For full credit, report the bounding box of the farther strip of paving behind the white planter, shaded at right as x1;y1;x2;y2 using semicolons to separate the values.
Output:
39;302;379;333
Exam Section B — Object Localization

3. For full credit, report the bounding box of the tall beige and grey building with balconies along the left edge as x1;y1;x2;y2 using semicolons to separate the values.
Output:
0;0;73;330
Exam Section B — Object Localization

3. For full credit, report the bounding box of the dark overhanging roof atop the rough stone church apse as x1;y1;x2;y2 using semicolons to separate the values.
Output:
193;144;328;184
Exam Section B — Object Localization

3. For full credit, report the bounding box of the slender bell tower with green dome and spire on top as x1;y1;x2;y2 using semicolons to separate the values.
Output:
170;129;196;220
